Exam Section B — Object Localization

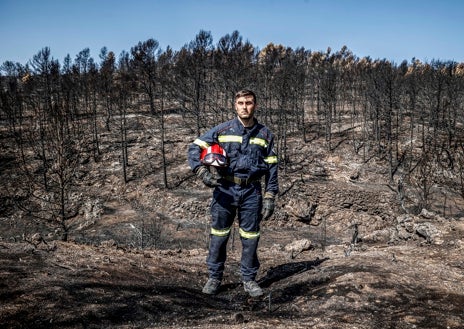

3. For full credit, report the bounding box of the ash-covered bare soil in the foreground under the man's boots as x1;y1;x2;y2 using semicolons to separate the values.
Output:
0;215;464;328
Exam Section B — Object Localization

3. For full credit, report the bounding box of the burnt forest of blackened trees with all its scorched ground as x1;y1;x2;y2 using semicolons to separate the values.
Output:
0;30;464;329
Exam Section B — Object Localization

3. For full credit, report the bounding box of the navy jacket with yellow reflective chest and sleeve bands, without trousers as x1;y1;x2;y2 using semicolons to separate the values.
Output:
188;118;279;195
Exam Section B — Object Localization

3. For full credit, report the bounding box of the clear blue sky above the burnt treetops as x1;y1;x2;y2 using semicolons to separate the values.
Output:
0;0;464;65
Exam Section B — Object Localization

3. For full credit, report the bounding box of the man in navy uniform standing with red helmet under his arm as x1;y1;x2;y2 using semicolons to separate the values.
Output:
188;90;279;297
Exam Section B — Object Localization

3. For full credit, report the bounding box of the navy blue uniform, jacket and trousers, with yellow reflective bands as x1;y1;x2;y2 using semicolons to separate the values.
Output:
188;118;279;281
